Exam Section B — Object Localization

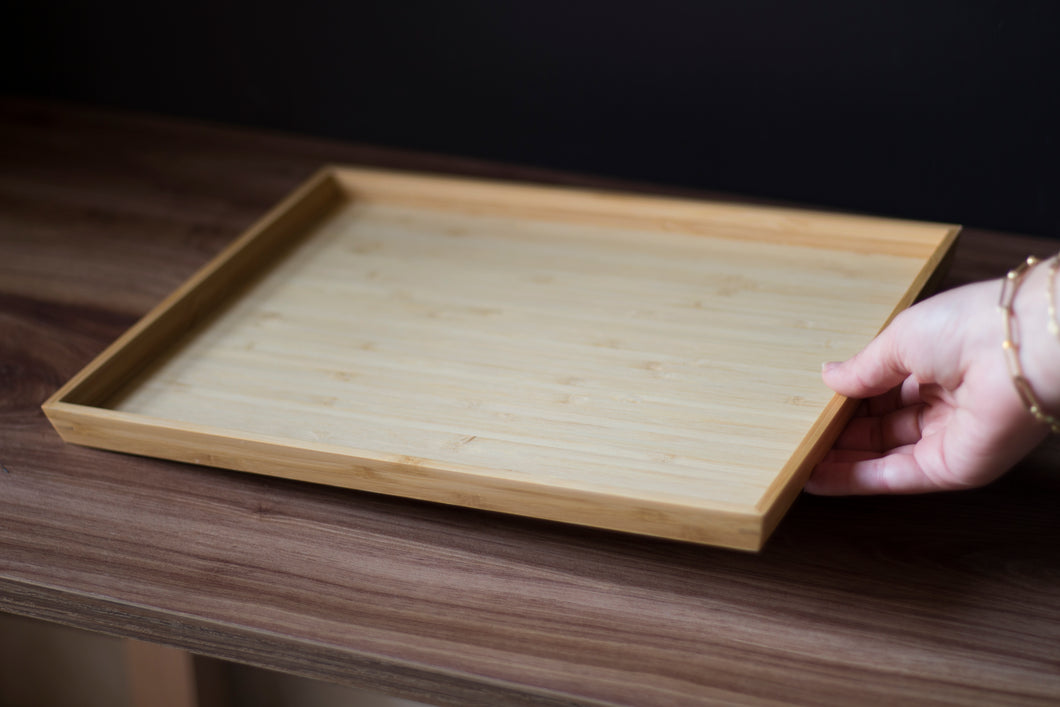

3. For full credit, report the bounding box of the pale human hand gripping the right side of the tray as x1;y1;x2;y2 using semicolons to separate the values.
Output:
806;267;1060;495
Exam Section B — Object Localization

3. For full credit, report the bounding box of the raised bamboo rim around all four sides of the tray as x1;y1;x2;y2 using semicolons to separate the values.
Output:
41;165;960;551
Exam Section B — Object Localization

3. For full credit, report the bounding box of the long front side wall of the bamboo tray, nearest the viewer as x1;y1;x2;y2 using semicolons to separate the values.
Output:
50;403;765;551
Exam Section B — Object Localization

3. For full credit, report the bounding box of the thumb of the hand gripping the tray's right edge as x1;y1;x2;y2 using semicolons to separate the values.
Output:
822;317;909;397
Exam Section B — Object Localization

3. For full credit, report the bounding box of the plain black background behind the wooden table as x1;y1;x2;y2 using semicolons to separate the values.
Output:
8;0;1060;236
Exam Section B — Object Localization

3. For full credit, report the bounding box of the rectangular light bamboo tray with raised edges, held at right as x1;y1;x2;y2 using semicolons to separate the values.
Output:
43;167;958;549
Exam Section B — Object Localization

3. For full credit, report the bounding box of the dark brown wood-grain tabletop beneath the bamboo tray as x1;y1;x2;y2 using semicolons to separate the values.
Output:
0;100;1060;705
